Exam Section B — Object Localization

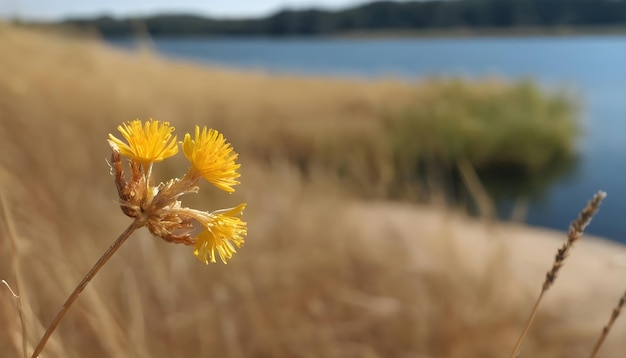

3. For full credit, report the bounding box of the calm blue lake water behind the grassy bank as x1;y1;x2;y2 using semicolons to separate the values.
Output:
111;36;626;243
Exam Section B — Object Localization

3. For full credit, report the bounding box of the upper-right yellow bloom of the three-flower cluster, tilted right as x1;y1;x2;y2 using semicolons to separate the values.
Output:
183;126;240;193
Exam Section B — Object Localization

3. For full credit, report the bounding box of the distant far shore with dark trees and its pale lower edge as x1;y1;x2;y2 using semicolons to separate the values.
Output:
33;0;626;38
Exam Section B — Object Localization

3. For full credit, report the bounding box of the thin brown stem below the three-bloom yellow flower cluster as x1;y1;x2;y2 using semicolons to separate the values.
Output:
31;219;144;358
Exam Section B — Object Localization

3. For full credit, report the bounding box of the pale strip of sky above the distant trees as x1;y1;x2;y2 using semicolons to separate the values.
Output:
0;0;368;20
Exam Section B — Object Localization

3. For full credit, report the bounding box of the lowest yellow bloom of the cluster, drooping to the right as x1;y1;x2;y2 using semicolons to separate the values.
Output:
193;204;248;265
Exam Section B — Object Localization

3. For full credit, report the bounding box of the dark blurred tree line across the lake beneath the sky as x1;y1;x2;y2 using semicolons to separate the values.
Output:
62;0;626;36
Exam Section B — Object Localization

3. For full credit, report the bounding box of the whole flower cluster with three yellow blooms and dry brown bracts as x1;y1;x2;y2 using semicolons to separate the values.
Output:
109;120;247;264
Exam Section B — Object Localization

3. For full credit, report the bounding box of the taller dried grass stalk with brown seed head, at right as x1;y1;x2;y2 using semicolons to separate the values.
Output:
510;191;606;358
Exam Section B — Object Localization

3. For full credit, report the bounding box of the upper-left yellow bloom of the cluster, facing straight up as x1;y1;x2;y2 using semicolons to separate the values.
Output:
109;119;178;164
